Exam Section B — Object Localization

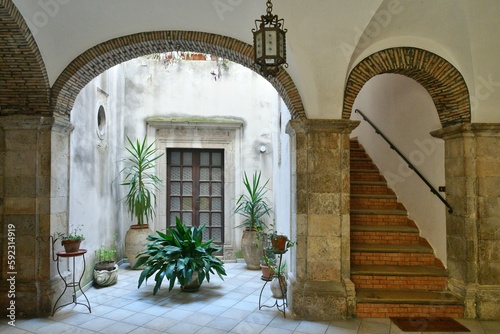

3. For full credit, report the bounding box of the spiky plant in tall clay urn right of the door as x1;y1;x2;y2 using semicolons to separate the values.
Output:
234;172;272;269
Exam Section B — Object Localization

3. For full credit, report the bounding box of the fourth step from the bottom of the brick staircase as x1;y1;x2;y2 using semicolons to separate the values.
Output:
351;225;420;244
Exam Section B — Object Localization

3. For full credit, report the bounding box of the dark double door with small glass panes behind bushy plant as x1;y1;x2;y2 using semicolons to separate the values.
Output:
167;149;224;245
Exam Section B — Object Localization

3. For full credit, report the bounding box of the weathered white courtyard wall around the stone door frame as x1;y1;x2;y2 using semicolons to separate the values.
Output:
70;57;289;270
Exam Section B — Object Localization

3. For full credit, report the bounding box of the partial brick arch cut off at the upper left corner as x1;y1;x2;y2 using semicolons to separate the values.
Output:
0;0;50;116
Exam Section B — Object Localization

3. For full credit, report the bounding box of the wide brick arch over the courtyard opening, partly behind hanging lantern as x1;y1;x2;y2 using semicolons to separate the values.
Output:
52;31;306;119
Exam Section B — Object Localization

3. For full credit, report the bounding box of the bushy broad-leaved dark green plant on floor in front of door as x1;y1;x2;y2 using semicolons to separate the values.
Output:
135;217;226;294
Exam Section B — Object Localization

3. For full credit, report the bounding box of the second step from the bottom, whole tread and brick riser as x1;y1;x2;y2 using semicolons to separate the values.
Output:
351;265;448;291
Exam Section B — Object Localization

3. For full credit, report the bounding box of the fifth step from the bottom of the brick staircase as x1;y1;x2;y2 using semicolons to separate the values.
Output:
351;209;409;226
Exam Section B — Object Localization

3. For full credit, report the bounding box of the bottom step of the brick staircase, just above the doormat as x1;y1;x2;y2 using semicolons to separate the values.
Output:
356;289;464;318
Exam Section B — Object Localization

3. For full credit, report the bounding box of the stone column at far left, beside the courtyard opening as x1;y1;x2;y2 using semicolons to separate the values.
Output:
0;116;69;318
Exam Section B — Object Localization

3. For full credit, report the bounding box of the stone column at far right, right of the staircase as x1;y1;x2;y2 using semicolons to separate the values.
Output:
432;124;500;319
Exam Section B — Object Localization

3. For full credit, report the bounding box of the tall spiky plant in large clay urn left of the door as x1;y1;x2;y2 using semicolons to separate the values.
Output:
121;136;163;267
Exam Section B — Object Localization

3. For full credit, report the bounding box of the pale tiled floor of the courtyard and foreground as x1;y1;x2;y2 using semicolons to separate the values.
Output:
0;263;500;334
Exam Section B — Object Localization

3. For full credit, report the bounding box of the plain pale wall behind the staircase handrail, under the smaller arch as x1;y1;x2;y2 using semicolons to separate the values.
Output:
351;74;447;265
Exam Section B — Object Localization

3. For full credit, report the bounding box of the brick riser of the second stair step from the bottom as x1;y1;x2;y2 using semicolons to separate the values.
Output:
351;275;447;291
